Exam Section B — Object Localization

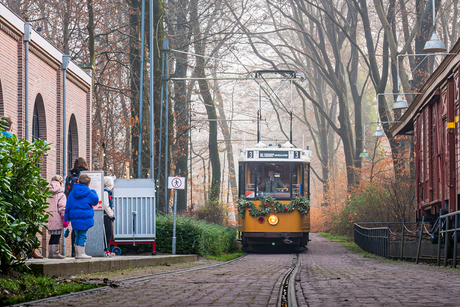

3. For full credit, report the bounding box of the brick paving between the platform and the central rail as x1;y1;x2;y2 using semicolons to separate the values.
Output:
34;254;295;307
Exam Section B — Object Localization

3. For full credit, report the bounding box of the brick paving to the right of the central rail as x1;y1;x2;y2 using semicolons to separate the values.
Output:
296;234;460;307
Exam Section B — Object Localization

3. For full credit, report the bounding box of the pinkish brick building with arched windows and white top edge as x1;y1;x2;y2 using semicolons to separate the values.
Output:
0;3;91;255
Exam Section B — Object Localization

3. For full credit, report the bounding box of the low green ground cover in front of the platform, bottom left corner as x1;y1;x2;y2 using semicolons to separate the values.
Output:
0;274;98;306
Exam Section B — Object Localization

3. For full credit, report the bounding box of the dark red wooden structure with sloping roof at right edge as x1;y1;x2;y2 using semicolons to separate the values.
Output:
391;40;460;218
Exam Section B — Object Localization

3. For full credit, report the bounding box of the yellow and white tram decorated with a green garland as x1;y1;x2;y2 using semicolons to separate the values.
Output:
237;142;311;250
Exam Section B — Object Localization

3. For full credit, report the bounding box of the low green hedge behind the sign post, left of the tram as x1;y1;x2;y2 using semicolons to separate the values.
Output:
156;215;237;256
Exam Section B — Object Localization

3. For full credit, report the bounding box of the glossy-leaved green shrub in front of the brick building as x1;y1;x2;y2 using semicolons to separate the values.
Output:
0;136;50;273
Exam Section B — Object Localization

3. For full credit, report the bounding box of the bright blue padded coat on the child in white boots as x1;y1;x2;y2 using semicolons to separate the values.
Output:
64;183;99;230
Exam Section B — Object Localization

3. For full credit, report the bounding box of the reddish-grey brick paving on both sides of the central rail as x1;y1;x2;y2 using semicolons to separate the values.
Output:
28;234;460;307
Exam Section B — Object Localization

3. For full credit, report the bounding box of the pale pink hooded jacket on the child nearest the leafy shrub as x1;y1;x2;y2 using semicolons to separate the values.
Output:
46;181;66;230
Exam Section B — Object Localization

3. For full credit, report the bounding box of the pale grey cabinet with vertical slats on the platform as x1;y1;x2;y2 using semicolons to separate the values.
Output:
113;179;156;245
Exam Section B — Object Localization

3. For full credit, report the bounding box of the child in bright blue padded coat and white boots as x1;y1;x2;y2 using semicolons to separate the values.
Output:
64;173;99;259
